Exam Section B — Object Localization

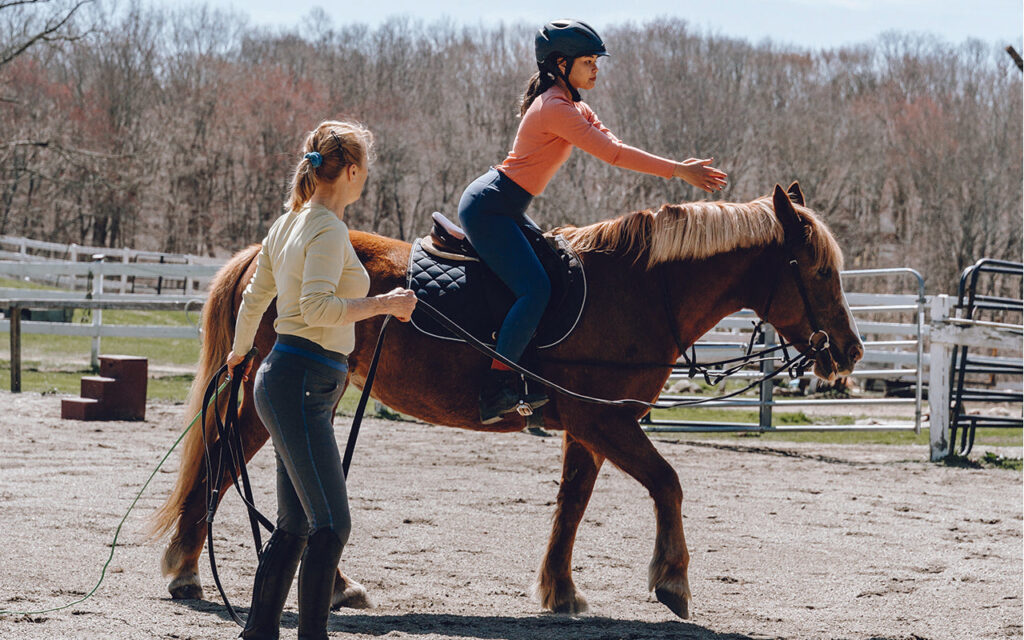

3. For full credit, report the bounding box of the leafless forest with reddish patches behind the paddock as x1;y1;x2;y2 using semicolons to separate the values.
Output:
0;0;1024;293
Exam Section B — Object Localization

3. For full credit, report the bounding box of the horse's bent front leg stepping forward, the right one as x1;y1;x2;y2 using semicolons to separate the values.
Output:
574;416;691;618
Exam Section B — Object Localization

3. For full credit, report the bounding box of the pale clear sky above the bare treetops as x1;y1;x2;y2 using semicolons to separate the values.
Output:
193;0;1024;49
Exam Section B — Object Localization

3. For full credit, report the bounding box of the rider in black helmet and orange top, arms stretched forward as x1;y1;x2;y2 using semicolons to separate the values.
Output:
459;20;727;424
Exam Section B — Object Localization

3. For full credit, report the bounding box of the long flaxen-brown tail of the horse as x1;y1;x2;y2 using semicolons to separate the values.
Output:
148;245;259;539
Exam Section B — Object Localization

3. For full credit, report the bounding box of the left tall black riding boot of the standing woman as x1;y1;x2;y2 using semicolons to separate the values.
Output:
239;528;306;640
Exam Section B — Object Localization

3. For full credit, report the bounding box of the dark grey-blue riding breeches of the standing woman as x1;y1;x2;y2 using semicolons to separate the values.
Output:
253;334;351;545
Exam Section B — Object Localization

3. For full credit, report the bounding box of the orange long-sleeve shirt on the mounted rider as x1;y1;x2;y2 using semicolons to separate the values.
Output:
496;86;676;196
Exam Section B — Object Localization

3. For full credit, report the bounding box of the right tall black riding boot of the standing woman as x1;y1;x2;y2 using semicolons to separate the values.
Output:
299;528;344;640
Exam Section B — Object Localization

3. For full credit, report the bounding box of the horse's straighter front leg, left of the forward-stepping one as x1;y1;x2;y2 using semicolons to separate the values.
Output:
535;432;604;613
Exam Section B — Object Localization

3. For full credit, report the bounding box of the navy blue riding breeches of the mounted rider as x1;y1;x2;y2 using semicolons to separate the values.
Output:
459;168;551;361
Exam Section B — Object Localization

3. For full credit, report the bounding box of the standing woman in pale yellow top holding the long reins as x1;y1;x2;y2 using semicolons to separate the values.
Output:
227;122;416;640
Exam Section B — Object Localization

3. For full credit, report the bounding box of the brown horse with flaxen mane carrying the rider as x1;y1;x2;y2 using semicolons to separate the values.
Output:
146;183;863;617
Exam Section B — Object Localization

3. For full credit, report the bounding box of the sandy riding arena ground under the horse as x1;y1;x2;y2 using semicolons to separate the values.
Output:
0;393;1024;640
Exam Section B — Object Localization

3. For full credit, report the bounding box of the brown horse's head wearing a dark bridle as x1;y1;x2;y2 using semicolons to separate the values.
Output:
761;182;864;382
